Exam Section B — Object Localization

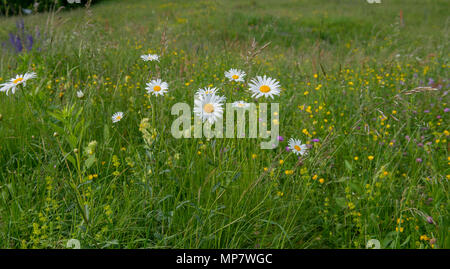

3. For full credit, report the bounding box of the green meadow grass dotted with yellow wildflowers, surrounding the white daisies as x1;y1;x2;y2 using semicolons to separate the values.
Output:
0;0;450;248
